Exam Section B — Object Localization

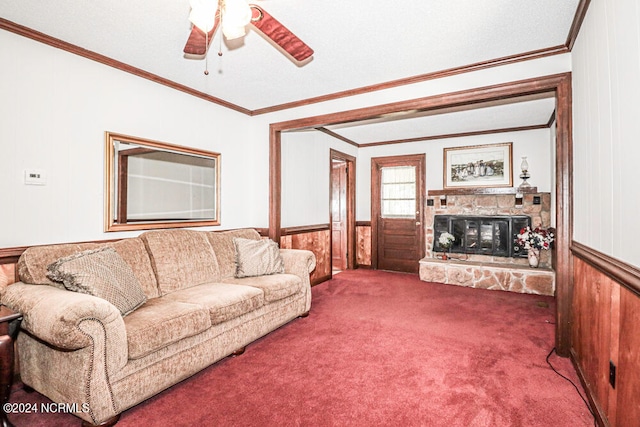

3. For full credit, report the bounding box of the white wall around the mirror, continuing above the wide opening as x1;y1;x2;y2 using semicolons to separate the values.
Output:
0;25;571;247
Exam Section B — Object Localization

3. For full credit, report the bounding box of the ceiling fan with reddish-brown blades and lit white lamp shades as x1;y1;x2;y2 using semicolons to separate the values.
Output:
184;0;313;62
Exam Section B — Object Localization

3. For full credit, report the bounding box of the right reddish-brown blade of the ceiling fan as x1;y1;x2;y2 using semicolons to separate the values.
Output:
249;4;313;61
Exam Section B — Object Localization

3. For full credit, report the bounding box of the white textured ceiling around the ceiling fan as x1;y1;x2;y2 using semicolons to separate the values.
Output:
0;0;579;143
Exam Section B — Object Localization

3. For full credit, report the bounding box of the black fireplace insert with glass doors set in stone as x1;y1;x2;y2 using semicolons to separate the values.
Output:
433;215;531;258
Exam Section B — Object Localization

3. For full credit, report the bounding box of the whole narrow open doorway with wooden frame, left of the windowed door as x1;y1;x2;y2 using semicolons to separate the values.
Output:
329;150;356;275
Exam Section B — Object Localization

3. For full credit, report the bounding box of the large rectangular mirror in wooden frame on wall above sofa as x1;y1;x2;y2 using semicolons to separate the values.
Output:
104;132;220;231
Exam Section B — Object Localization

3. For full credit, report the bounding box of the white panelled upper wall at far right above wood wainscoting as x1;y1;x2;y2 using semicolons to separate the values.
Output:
572;0;640;266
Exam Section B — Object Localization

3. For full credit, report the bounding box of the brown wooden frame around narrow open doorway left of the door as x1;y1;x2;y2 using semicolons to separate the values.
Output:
329;148;356;277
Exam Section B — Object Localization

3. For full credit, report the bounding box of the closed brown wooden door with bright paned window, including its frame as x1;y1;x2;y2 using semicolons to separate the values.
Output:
371;154;426;273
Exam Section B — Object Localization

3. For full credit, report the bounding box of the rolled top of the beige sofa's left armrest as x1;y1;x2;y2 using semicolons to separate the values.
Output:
2;282;127;352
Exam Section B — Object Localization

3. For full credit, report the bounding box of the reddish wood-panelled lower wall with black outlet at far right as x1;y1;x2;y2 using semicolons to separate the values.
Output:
571;243;640;427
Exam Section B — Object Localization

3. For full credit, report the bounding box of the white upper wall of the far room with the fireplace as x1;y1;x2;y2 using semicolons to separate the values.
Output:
282;129;555;227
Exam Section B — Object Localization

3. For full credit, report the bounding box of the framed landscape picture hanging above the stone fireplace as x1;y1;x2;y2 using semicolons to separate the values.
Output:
443;142;513;189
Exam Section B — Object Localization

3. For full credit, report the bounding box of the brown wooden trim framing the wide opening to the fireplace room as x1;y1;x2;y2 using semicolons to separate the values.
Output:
269;72;573;357
